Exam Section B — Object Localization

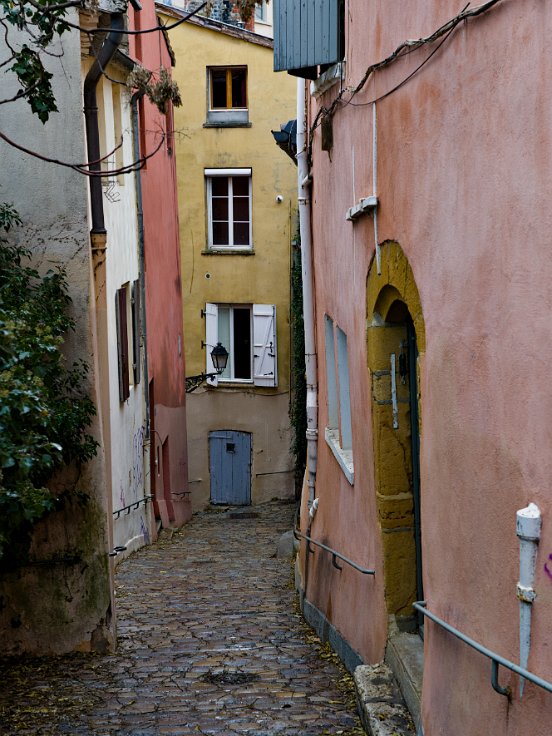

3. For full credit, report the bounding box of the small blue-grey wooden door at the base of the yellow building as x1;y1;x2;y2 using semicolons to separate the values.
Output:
209;430;251;506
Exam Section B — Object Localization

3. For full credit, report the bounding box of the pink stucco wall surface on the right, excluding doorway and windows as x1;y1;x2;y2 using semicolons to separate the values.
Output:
308;0;552;736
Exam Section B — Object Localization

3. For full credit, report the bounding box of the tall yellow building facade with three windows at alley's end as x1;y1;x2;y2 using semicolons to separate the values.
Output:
162;7;296;509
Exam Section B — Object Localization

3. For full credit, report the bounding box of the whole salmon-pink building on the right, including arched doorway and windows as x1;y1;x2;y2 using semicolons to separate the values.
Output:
274;0;552;736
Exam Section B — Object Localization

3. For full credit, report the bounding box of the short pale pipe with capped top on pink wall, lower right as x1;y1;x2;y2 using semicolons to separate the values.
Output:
516;503;541;698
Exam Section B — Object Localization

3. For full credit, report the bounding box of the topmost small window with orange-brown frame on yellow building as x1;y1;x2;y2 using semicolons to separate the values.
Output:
207;66;249;126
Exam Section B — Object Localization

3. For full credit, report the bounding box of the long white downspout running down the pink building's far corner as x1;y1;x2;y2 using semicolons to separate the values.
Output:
297;79;318;519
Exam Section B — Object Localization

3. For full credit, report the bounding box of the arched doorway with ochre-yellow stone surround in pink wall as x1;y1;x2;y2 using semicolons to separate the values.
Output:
367;243;425;635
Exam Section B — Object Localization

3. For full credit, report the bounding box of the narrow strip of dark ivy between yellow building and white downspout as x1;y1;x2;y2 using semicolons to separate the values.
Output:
289;235;307;499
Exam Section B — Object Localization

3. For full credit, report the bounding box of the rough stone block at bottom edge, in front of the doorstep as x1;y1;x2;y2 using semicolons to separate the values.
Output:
354;663;416;736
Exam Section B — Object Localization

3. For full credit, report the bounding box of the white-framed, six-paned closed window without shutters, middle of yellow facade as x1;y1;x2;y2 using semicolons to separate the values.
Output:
205;169;253;250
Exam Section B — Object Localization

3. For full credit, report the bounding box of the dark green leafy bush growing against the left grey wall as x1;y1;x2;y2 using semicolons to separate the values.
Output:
0;203;97;562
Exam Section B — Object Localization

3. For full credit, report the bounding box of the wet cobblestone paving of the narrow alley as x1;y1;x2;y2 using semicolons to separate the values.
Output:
0;502;363;736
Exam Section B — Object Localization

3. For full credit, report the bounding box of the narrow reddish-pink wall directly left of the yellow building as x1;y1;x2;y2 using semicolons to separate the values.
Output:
129;0;191;526
